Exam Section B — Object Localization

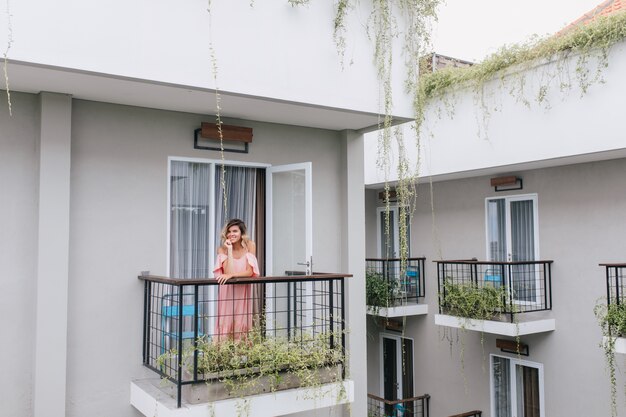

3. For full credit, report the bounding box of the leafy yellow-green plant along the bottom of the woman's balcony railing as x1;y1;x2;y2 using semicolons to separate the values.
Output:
157;330;346;415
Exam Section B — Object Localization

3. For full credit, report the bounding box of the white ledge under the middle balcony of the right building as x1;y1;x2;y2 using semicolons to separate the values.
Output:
435;314;556;337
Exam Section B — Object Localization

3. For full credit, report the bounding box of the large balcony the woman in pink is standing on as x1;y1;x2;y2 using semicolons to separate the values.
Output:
131;274;353;417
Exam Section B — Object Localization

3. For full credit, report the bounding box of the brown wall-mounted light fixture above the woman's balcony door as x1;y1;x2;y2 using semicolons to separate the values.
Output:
193;122;252;153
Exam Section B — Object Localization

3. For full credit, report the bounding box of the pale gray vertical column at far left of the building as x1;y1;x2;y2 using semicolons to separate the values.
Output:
33;93;72;417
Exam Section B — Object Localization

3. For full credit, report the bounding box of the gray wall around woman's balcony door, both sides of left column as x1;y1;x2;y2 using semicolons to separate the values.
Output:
0;94;358;417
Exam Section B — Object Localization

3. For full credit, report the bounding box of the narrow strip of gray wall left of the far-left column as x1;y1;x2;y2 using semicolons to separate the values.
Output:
0;90;39;416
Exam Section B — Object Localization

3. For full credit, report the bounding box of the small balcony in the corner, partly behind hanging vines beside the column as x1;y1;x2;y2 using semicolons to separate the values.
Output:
365;258;428;317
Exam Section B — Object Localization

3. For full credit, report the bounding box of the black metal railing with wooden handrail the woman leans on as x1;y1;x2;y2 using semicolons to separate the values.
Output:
138;274;351;407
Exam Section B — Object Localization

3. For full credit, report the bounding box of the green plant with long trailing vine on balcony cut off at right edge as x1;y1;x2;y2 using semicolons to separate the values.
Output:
593;300;626;417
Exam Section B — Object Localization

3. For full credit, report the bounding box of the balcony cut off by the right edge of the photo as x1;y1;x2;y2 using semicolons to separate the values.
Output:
600;264;626;354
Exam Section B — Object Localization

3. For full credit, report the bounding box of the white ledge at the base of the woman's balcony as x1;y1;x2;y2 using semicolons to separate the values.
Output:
130;378;354;417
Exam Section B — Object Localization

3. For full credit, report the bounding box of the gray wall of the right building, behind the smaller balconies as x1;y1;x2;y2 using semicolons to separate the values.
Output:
368;159;626;417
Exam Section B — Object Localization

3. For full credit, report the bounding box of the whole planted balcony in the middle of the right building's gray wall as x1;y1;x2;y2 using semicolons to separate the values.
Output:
435;260;556;337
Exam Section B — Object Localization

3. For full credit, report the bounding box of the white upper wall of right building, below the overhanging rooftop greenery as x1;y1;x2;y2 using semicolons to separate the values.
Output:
365;41;626;184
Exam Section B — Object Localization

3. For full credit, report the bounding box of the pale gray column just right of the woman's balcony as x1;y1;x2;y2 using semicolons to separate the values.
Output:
341;131;367;416
